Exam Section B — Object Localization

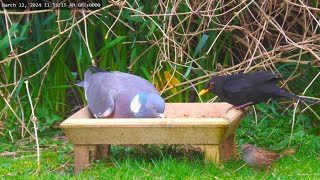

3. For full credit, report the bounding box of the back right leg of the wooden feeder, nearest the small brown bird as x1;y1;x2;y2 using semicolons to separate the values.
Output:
220;133;237;161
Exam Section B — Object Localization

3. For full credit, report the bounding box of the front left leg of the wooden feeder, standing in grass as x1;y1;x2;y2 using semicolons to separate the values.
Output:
74;145;92;174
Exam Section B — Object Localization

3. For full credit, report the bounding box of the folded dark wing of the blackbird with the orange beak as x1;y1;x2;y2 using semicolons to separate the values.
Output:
224;71;278;93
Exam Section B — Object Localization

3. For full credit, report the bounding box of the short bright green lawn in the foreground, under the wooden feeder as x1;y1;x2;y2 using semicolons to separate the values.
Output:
0;130;320;179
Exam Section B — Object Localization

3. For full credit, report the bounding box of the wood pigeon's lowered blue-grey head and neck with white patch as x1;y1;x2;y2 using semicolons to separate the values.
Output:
130;93;165;118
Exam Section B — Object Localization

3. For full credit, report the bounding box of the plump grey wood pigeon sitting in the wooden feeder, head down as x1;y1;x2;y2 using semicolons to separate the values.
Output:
74;67;165;118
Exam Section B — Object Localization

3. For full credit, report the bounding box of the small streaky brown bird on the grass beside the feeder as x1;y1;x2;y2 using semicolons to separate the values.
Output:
241;144;294;169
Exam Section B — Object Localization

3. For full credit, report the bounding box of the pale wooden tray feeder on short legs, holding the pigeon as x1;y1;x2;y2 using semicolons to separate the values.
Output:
60;103;244;174
